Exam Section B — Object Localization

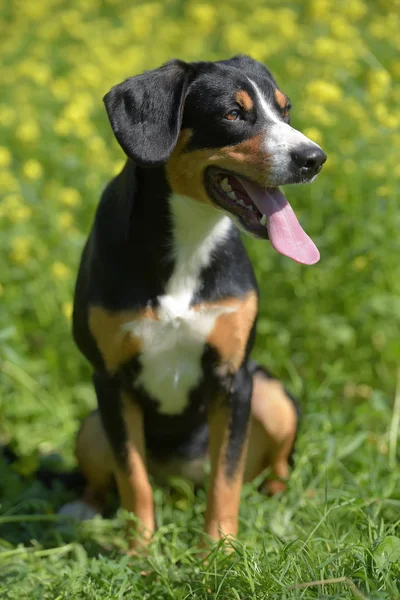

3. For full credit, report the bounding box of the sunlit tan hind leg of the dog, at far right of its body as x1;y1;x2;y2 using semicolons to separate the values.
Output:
245;372;297;494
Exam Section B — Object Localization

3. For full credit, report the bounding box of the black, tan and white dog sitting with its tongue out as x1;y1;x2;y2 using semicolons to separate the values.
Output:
63;56;326;552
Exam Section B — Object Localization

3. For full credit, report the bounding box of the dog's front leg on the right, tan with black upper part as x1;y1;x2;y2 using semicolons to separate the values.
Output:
205;367;253;540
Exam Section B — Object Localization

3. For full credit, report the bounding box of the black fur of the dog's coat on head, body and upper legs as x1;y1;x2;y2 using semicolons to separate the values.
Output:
73;57;300;488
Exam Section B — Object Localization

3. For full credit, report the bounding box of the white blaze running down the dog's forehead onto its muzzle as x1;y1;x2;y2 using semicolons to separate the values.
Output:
249;78;320;185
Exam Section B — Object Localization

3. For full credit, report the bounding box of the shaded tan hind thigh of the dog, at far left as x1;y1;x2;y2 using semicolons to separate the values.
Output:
75;412;114;513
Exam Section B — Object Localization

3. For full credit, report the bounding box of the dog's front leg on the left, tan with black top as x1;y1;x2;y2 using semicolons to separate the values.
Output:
94;376;155;553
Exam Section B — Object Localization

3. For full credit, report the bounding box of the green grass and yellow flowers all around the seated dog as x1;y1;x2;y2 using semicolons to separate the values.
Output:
0;0;400;600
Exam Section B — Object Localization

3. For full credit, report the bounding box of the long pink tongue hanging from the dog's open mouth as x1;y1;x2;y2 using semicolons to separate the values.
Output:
238;177;319;265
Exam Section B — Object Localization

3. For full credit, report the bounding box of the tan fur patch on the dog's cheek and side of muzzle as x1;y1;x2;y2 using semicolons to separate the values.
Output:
166;129;270;206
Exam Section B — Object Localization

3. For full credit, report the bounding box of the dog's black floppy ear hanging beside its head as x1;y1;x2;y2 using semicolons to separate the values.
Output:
104;60;192;167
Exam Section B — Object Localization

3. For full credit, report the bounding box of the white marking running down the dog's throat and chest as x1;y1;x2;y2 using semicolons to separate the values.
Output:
124;196;232;415
